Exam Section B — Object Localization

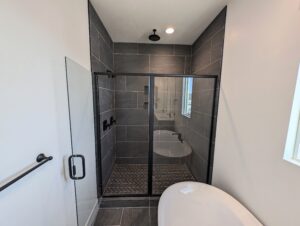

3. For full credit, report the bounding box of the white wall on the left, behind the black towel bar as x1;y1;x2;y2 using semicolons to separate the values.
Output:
0;0;90;226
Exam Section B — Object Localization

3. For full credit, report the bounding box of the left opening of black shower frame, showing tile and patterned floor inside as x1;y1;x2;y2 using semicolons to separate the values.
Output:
98;76;149;196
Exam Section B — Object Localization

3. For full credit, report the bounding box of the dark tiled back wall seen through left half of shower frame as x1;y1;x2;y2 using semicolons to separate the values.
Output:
115;76;149;164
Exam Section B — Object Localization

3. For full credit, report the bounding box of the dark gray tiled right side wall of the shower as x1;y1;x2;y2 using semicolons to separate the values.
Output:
175;8;226;182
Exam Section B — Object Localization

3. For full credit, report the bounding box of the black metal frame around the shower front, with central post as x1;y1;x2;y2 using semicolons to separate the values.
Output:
92;71;219;198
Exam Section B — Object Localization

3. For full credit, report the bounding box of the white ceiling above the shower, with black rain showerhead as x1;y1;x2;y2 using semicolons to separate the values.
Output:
91;0;227;45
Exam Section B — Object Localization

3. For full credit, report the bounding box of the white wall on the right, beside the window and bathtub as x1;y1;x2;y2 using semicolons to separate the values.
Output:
213;0;300;226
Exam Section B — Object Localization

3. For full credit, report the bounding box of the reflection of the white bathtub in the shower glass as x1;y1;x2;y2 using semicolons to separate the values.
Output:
153;130;192;158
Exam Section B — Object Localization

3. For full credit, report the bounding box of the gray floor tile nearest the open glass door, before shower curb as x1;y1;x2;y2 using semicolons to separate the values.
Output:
94;208;123;226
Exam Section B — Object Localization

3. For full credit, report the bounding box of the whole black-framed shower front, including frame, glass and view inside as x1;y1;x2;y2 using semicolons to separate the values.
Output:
94;73;217;197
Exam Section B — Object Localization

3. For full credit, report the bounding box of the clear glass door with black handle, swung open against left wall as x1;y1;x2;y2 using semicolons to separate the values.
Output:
66;58;97;226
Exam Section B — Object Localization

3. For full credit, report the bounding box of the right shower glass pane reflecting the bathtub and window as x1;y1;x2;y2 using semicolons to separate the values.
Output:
152;77;215;195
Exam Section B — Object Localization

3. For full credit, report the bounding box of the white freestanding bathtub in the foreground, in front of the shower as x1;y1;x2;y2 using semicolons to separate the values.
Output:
158;182;262;226
